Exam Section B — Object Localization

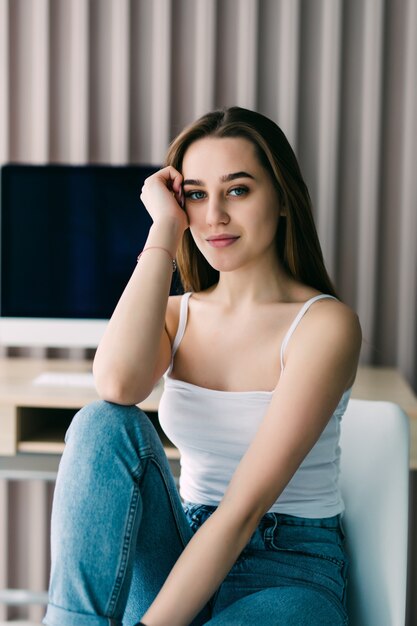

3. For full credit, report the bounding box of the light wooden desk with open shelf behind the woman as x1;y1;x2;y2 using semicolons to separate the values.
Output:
0;358;417;469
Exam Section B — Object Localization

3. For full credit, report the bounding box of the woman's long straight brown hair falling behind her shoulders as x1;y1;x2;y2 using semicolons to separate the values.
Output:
166;107;336;295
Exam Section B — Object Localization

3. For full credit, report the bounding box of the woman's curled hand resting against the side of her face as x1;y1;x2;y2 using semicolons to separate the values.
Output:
140;165;188;231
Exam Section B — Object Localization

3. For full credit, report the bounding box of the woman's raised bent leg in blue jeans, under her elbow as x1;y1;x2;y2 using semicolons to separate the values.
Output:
44;402;208;626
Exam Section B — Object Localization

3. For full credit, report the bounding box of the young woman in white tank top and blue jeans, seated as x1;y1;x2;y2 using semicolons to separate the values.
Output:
45;107;361;626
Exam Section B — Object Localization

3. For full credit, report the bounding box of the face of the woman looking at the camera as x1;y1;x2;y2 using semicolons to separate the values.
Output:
182;137;280;271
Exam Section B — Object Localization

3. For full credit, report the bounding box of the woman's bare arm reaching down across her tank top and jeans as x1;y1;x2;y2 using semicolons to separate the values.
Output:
142;301;361;626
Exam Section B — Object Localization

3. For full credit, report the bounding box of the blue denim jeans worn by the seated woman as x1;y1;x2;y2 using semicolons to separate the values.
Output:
44;401;347;626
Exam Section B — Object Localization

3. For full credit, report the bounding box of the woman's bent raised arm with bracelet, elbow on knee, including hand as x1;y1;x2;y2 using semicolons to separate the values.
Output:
93;167;188;404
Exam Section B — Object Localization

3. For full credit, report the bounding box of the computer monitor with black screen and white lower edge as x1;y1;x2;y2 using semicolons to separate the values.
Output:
0;164;162;348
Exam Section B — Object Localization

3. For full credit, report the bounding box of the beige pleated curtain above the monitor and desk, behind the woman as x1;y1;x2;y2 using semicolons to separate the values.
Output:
0;0;417;390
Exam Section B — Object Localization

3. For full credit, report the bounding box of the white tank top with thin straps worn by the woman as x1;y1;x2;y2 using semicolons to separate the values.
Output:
159;293;350;518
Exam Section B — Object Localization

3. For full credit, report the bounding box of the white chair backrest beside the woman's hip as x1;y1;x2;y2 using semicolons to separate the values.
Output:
340;400;409;626
